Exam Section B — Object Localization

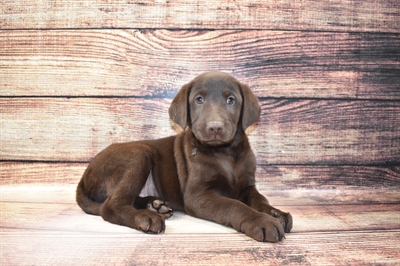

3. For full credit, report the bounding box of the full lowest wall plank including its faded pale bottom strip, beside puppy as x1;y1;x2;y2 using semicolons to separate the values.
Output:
0;166;400;207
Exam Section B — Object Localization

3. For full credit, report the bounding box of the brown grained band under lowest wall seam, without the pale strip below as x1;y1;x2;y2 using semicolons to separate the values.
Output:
0;162;400;191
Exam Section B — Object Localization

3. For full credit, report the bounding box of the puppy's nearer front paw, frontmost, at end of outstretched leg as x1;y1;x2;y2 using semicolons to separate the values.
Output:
241;214;285;242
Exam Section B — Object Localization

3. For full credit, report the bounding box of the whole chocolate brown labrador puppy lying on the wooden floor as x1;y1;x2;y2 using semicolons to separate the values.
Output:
76;72;292;242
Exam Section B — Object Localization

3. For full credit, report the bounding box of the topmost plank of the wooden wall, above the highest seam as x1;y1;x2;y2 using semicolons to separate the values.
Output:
0;0;400;32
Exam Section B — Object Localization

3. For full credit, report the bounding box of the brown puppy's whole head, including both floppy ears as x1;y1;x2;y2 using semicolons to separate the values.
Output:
169;71;261;146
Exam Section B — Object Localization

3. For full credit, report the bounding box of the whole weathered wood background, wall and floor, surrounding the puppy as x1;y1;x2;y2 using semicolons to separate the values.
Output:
0;0;400;265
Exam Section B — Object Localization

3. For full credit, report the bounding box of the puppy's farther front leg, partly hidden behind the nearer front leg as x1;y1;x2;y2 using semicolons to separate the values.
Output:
240;187;293;233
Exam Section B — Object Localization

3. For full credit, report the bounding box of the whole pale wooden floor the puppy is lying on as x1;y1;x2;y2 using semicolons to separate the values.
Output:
0;185;400;265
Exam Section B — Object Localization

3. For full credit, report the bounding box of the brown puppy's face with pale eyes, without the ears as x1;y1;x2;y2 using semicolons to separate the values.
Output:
188;73;243;146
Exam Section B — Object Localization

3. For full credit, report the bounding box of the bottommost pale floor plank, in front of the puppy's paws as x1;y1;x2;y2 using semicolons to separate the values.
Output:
0;228;400;265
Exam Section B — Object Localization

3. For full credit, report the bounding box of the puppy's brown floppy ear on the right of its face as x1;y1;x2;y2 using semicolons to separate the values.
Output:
240;84;261;130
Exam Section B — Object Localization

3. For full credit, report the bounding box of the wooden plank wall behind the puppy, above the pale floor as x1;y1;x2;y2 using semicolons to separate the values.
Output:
0;0;400;201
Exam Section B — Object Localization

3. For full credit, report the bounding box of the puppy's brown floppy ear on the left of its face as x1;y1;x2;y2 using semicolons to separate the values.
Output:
168;82;192;130
